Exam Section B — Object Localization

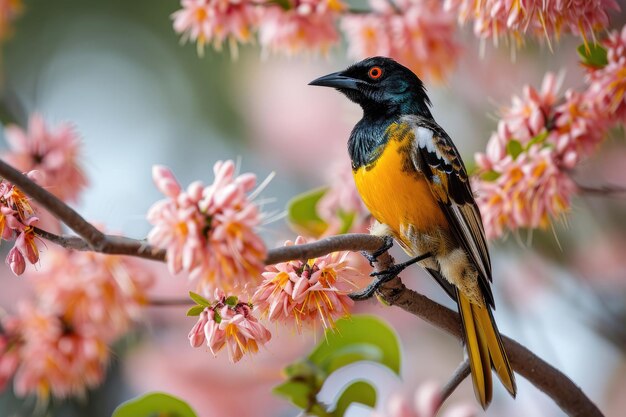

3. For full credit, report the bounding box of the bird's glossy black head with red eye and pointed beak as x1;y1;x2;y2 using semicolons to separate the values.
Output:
309;57;431;117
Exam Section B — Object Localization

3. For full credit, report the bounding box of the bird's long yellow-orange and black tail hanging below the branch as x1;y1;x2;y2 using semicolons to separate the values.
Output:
457;290;517;409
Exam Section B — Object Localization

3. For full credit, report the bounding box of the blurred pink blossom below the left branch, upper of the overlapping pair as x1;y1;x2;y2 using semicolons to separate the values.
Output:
29;247;155;342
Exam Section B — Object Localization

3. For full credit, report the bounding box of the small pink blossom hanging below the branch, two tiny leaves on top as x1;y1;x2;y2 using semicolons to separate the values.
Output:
189;289;272;362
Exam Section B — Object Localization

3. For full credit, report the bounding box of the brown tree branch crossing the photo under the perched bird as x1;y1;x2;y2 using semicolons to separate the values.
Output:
0;160;602;417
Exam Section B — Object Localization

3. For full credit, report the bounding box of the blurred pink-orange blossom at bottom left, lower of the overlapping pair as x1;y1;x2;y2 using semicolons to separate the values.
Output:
8;304;109;403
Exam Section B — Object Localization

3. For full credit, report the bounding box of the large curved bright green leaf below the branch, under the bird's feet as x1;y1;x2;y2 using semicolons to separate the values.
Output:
309;315;400;375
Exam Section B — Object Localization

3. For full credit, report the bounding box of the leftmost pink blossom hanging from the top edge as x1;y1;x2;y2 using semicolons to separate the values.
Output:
172;0;258;55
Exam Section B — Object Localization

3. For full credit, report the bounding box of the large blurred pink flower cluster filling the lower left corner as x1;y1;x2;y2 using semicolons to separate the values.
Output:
0;249;154;403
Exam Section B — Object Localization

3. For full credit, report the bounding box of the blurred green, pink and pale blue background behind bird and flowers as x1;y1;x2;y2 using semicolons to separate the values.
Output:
0;0;626;417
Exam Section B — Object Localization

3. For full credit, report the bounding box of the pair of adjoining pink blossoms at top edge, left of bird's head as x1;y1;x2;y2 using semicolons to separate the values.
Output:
172;0;345;54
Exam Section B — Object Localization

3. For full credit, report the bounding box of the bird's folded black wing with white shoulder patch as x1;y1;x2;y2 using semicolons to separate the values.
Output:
403;116;494;307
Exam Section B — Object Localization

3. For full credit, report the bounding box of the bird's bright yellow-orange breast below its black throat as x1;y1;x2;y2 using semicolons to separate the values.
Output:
353;130;447;243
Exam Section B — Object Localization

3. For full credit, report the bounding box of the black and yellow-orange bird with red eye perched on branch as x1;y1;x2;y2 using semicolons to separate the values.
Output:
309;57;517;409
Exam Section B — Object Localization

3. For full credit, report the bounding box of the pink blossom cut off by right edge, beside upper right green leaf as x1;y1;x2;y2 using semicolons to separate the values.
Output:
585;26;626;123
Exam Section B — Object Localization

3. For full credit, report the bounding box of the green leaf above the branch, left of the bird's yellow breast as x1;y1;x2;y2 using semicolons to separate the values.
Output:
287;187;328;237
